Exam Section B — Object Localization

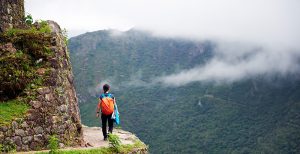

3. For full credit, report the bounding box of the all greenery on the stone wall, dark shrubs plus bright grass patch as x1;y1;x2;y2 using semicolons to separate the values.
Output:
0;21;54;127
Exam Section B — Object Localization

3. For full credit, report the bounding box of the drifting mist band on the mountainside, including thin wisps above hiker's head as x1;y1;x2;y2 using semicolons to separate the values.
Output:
95;38;300;91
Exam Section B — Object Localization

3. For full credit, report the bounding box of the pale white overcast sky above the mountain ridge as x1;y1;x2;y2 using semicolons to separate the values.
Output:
25;0;300;47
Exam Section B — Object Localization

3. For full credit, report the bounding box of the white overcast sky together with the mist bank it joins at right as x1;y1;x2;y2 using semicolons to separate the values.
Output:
25;0;300;85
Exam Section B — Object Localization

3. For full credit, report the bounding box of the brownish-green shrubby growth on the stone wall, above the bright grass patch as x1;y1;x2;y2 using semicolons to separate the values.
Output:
0;21;54;101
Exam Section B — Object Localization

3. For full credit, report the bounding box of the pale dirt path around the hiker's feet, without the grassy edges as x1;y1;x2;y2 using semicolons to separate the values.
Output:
17;126;138;154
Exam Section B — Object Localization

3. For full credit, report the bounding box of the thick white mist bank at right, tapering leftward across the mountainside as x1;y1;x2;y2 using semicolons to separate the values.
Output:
155;43;300;86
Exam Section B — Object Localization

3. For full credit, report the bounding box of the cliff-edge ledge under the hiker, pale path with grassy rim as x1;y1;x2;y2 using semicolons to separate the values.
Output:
17;126;148;154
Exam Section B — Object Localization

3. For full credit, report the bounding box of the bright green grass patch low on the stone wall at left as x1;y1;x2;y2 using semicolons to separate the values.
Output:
0;99;29;125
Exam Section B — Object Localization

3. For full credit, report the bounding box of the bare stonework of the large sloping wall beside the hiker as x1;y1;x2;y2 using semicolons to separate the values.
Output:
0;21;83;151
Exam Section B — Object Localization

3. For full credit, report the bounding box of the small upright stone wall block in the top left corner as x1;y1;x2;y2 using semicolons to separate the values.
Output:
0;0;25;32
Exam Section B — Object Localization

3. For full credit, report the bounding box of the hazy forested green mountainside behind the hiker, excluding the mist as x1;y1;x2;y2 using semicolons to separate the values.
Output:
69;30;300;153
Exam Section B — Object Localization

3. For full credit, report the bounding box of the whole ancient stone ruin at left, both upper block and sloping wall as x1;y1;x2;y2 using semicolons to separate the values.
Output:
0;0;83;153
